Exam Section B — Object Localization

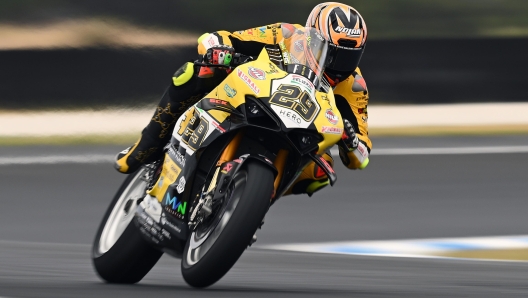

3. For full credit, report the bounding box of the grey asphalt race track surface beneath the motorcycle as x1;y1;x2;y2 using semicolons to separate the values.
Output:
0;135;528;298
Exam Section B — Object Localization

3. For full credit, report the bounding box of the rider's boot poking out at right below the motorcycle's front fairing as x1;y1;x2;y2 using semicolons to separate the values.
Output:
286;152;334;196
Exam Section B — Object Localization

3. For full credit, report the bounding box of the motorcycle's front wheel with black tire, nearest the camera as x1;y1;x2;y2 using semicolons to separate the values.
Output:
181;160;274;288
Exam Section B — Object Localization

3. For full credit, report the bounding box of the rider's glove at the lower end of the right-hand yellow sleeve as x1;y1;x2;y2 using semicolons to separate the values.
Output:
338;119;369;169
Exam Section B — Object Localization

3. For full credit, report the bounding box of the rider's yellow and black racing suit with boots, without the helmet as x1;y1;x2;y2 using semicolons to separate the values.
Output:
116;23;371;195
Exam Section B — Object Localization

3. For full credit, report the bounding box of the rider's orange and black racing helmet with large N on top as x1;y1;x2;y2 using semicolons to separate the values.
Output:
306;2;367;83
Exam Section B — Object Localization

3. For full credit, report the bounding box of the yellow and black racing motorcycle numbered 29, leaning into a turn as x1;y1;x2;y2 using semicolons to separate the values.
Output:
92;28;343;288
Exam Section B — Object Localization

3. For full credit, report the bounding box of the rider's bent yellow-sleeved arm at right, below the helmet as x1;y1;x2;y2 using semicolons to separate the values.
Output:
334;68;372;169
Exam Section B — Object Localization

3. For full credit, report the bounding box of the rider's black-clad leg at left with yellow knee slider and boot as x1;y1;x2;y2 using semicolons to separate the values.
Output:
115;62;205;174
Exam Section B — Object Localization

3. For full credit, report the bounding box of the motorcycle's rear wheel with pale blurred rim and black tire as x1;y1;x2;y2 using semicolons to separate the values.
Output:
92;168;163;284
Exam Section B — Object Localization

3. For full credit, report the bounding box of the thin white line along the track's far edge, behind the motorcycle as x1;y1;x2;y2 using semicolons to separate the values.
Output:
0;146;528;166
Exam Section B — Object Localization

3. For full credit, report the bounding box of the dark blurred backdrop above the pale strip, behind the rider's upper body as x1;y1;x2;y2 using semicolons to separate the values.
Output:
0;0;528;110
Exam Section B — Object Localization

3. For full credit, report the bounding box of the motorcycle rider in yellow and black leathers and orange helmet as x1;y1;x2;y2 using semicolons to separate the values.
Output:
115;2;372;195
